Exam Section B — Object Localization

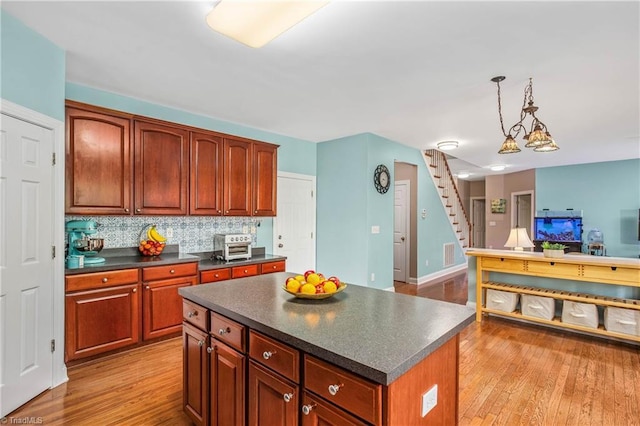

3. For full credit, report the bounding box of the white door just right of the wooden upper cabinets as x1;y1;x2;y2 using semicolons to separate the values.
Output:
273;172;316;273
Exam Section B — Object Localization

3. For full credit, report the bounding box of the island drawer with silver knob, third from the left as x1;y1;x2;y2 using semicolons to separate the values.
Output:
249;330;300;383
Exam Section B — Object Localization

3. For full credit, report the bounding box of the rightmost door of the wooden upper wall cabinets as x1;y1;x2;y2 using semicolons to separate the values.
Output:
251;143;278;216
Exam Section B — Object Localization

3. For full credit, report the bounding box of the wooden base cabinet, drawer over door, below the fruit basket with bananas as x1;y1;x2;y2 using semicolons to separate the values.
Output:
142;263;198;340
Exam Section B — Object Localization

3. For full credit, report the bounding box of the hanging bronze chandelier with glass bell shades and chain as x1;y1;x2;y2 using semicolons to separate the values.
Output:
491;76;560;154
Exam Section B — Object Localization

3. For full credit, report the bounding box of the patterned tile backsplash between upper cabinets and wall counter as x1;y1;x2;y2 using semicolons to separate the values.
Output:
65;216;260;253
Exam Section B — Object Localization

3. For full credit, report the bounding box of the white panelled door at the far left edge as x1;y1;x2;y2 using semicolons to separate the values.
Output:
0;114;54;417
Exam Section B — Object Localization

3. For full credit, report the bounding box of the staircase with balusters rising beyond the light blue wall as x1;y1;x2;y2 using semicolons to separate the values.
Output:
424;149;471;251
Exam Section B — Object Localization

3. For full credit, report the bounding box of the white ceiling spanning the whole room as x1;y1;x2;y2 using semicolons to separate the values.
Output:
2;0;640;178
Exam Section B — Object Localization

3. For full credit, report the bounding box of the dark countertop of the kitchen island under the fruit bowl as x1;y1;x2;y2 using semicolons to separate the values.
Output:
179;272;475;385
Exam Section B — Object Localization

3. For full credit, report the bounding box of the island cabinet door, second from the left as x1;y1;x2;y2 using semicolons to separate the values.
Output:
208;339;246;426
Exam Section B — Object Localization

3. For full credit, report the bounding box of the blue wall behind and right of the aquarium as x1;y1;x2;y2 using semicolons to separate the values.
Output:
536;159;640;258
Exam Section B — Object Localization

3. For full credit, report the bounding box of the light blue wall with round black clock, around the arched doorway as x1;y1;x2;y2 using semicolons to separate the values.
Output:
317;133;466;288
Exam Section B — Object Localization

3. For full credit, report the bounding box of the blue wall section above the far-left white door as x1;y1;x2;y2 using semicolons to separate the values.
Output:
0;9;65;121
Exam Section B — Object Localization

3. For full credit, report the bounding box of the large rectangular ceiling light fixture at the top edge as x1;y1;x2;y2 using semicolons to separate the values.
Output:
207;0;329;48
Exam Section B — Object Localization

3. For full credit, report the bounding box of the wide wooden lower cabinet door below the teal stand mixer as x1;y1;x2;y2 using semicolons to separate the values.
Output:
65;284;140;361
